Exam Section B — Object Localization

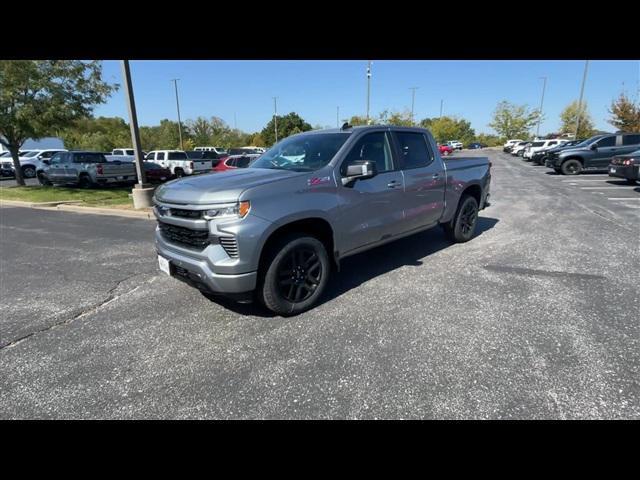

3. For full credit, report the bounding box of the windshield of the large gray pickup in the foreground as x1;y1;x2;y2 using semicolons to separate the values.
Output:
249;132;351;172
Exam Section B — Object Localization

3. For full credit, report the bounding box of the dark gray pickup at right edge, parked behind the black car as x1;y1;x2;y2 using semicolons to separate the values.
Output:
546;133;640;175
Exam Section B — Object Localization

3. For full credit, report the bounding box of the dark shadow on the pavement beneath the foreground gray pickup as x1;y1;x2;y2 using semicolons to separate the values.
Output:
207;217;499;318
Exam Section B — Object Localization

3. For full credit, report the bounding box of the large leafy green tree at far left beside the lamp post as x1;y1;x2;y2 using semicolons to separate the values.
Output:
0;60;118;185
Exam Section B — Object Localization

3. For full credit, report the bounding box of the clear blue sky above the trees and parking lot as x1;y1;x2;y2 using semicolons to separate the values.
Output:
95;59;640;133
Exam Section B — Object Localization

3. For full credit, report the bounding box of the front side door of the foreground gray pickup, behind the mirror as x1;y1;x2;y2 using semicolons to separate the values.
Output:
336;131;404;253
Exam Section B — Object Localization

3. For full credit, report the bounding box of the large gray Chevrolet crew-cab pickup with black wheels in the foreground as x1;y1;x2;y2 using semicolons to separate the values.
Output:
154;124;491;315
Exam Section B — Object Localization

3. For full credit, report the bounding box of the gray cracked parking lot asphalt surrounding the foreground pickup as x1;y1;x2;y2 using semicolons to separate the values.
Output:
0;150;640;419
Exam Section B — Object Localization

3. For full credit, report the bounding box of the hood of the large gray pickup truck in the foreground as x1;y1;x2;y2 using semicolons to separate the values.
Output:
154;168;308;205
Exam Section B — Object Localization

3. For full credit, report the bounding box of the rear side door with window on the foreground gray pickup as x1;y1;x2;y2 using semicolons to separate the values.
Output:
394;131;444;231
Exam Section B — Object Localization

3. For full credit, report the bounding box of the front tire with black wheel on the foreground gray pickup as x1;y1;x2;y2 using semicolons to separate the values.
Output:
257;233;331;316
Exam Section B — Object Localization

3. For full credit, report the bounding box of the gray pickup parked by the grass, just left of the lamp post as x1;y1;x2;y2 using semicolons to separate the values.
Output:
37;151;137;188
